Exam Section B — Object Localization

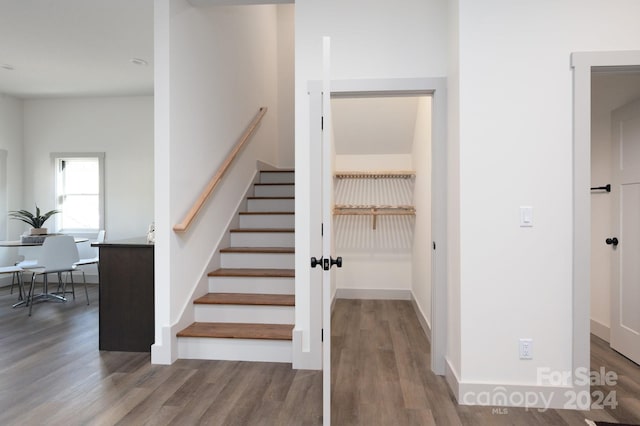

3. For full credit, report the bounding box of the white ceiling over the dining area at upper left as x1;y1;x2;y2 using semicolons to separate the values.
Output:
0;0;153;98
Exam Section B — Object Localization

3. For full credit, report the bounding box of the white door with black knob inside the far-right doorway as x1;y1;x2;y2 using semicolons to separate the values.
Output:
606;101;640;363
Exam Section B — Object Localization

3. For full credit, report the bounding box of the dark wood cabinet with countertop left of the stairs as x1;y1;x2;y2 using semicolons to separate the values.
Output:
93;238;155;352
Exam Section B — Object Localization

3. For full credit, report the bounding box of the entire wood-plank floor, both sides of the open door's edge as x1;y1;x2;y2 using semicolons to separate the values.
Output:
0;286;640;426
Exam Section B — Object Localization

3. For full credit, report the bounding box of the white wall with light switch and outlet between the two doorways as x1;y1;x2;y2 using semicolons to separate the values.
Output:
451;0;640;402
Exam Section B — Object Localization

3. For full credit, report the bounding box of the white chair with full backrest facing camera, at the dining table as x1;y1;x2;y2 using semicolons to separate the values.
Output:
24;235;81;316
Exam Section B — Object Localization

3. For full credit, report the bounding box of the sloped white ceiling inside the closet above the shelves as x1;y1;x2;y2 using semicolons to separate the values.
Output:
331;96;419;155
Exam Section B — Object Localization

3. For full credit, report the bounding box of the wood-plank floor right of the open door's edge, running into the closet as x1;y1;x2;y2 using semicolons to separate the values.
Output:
331;299;640;426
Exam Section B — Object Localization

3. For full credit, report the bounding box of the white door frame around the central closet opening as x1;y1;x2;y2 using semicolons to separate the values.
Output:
308;77;448;375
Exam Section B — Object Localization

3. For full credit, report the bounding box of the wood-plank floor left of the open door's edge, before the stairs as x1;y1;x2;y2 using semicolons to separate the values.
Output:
0;285;322;426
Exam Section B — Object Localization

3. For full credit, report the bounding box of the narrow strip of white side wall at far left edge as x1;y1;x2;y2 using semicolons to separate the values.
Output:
0;94;24;279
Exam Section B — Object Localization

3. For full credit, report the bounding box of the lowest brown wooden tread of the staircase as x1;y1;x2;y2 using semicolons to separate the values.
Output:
177;322;293;340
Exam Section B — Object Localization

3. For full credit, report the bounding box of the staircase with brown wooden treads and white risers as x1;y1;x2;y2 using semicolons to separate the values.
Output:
177;170;295;362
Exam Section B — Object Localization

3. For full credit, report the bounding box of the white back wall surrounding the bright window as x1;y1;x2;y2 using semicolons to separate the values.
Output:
23;96;153;240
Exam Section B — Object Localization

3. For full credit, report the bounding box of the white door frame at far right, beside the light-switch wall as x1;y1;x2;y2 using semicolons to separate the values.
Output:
571;51;640;409
